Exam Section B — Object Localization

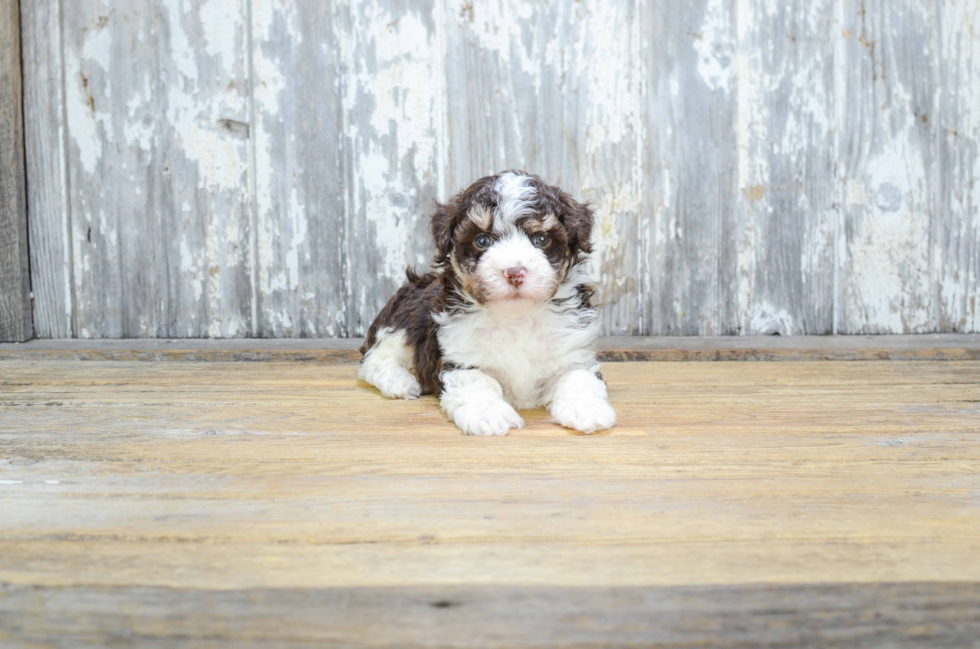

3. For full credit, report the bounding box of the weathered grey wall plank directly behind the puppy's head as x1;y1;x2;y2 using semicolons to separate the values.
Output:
444;0;644;334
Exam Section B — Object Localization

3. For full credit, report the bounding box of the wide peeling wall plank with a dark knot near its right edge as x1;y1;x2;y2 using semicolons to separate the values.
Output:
62;0;252;338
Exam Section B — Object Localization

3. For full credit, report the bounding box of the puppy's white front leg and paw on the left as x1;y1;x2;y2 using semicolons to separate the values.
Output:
440;370;524;435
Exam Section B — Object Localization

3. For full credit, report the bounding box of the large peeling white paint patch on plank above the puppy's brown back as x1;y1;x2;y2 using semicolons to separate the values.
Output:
343;2;442;294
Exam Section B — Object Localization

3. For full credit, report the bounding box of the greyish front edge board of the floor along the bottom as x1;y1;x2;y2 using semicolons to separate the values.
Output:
0;582;980;649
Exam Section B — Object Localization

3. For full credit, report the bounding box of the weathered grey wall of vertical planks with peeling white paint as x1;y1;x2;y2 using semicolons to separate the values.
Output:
22;0;980;337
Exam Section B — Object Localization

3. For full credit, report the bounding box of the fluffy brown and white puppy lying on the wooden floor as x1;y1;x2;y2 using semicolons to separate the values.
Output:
358;171;616;435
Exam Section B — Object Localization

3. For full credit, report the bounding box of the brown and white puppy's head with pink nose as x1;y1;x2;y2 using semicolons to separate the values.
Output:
432;171;593;311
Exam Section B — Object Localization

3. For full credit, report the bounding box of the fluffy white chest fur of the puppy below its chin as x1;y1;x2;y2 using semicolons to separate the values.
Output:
435;269;598;408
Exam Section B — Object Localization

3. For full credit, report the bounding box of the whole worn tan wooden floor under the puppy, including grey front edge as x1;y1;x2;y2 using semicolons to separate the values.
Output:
0;360;980;647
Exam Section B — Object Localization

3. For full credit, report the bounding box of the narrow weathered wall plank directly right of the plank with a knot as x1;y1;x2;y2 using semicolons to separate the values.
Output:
251;0;348;337
